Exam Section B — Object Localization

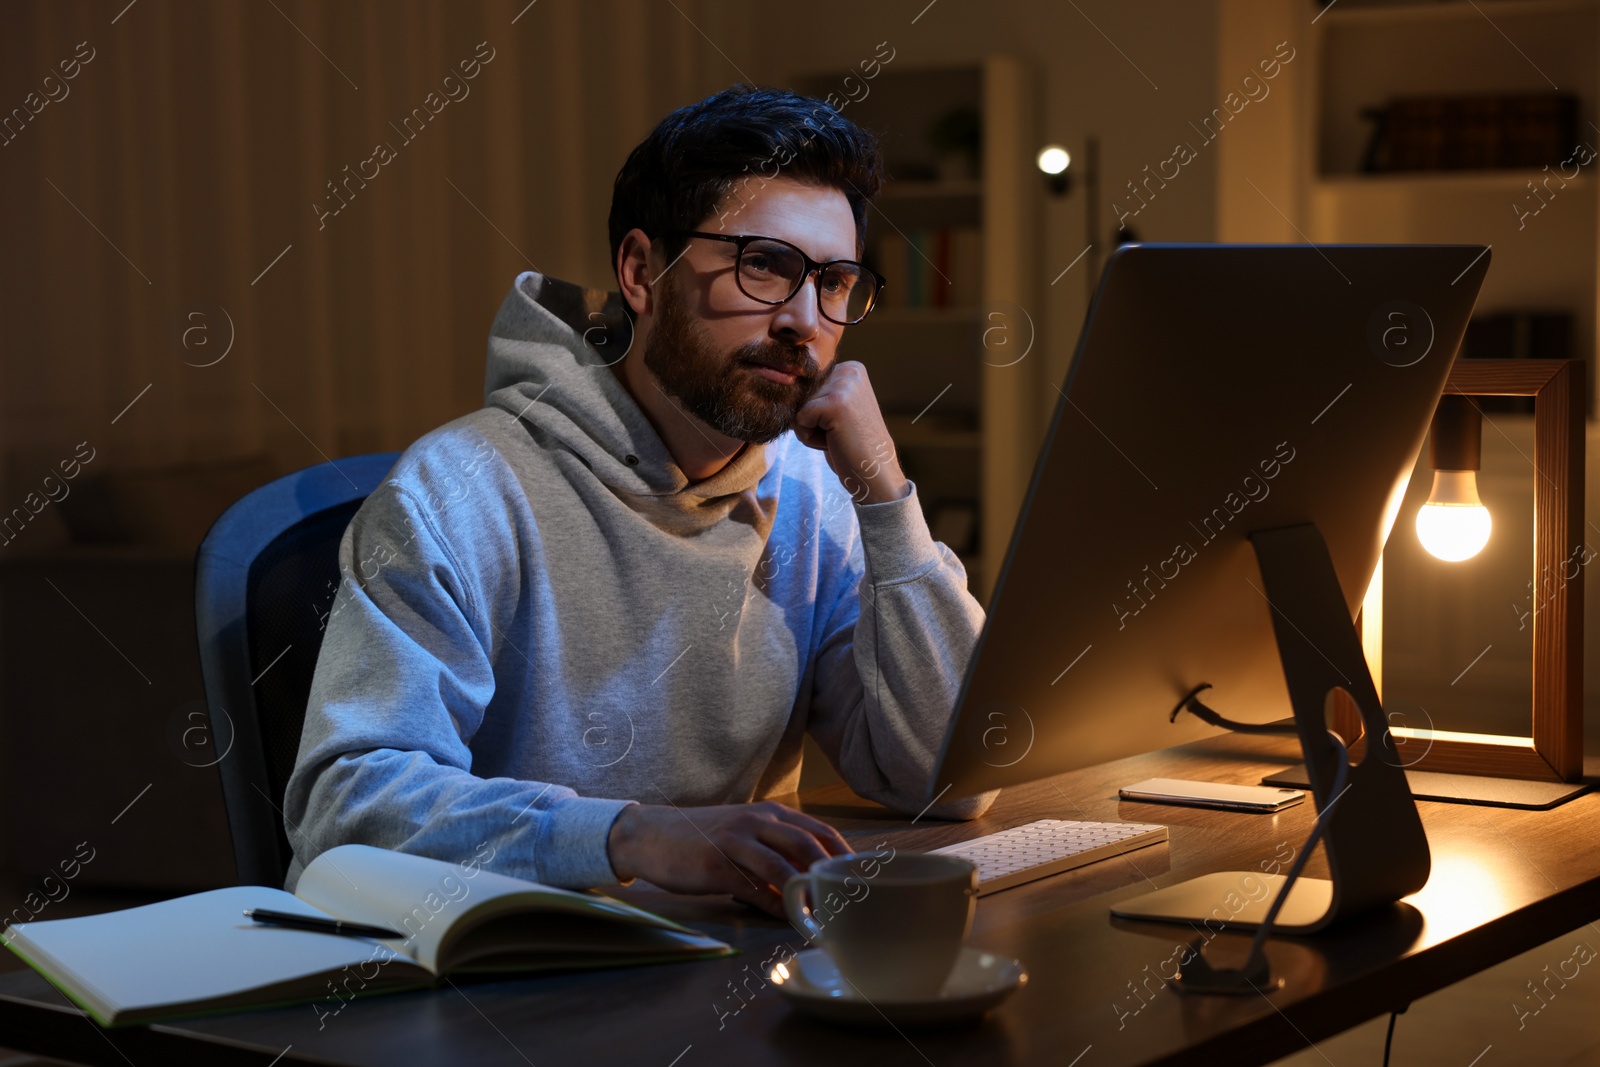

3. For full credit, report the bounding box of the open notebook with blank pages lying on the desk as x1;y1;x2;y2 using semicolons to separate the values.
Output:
5;845;734;1027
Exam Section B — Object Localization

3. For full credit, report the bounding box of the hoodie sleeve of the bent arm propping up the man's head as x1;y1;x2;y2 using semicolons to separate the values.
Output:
810;483;1000;819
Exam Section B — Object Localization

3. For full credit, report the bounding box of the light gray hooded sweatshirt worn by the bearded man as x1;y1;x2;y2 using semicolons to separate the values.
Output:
283;272;997;889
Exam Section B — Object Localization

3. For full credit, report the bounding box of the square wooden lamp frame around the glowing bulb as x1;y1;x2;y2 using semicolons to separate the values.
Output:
1333;358;1587;782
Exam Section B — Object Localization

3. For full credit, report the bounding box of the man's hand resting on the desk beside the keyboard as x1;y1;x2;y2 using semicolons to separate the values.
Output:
606;800;854;918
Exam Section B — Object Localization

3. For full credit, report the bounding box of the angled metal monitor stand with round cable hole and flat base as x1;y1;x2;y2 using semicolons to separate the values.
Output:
1110;523;1430;934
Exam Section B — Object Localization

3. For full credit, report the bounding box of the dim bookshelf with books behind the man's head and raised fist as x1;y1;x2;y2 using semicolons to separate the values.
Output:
795;56;1045;606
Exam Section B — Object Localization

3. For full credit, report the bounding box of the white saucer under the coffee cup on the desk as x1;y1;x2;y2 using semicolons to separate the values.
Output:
766;945;1027;1027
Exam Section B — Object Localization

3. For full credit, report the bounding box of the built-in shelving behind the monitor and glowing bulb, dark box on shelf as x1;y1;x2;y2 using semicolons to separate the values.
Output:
1218;0;1600;748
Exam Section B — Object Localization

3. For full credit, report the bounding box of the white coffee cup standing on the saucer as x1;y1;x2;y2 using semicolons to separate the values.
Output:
784;848;978;1000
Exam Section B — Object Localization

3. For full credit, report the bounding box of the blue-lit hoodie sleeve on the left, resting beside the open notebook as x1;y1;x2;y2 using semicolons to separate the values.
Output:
283;482;634;891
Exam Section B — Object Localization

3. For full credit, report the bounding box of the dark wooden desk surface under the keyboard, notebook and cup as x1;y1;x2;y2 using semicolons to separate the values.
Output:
0;736;1600;1067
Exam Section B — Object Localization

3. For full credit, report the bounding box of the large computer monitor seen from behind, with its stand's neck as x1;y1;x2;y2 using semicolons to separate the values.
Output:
928;245;1490;929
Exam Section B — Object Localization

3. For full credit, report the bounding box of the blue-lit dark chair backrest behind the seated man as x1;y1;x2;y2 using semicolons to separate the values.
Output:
195;453;400;889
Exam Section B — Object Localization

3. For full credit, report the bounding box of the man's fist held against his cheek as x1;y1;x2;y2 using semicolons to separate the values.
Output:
794;360;910;504
